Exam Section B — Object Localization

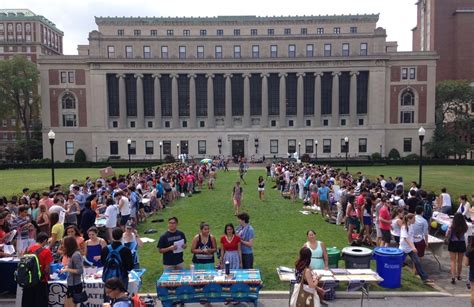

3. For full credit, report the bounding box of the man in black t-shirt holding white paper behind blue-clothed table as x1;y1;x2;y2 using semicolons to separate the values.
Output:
157;216;186;270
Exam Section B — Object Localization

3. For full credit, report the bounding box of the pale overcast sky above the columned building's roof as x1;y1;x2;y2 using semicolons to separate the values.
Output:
0;0;416;54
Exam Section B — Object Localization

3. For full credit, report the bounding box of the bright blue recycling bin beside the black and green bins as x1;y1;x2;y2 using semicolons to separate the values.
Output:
374;247;405;289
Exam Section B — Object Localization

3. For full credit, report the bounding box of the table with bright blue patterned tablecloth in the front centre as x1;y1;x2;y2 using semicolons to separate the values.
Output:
156;269;263;306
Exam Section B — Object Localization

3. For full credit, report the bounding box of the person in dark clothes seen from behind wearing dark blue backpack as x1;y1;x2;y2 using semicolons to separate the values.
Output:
101;227;133;289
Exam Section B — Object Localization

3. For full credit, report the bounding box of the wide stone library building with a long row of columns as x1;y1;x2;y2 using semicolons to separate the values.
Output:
39;15;437;161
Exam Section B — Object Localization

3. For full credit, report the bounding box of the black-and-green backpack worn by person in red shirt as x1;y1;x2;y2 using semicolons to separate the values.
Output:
14;247;44;288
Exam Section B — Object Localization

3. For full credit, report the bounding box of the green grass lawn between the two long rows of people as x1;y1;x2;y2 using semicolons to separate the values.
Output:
134;169;432;293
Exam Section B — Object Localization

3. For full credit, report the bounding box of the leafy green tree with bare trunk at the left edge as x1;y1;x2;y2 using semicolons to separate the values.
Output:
0;55;40;162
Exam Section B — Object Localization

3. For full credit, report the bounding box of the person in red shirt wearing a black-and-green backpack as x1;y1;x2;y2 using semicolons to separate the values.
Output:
21;232;53;307
